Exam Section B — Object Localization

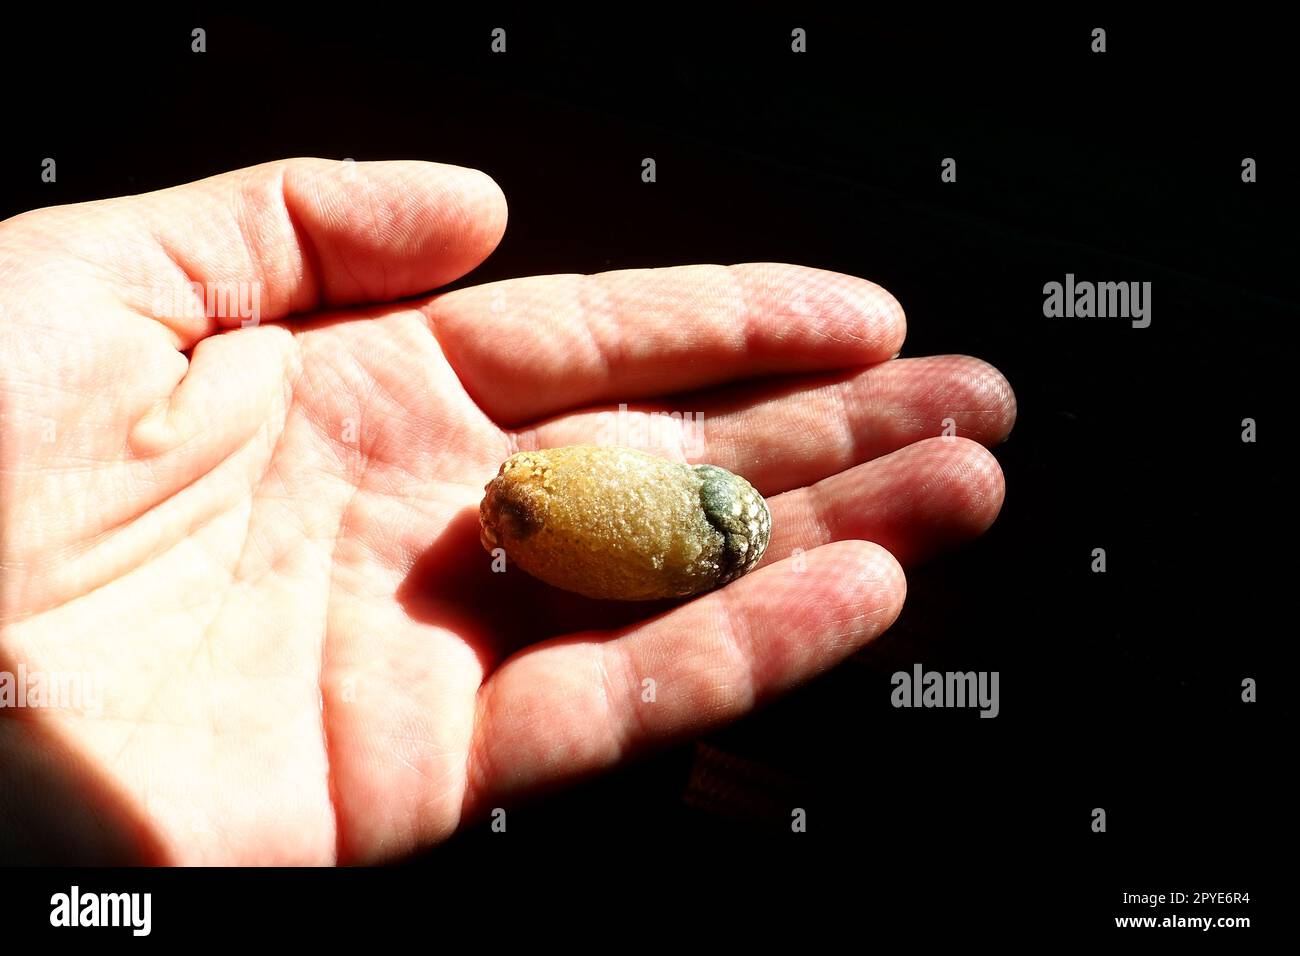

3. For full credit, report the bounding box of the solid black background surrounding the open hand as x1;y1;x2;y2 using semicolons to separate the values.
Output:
0;5;1297;938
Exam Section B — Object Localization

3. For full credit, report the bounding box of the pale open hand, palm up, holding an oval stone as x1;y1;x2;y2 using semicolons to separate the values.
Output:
0;160;1015;864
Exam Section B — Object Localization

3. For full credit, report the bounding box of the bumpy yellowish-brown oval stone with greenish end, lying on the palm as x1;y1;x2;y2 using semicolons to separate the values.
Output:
478;445;772;601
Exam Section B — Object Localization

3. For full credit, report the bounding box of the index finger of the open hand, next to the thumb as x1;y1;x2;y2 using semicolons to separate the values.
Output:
424;263;906;424
